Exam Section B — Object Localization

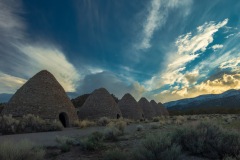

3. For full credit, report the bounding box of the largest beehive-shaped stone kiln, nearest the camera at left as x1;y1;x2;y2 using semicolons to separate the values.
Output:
2;70;77;126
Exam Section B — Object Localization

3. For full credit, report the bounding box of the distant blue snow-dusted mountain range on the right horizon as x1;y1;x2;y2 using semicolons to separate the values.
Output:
164;89;240;110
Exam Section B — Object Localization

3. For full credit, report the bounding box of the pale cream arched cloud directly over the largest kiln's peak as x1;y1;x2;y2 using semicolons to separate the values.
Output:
19;45;80;92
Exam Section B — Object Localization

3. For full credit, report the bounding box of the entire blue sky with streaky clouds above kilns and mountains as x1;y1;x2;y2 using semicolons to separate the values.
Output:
0;0;240;103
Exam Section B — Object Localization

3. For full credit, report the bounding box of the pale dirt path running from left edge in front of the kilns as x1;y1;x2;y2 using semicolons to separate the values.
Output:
0;124;147;146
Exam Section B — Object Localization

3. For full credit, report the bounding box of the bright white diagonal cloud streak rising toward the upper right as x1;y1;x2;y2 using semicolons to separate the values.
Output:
146;19;228;90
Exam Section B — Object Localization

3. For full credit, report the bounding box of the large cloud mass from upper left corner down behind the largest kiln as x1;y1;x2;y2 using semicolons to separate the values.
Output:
0;0;80;93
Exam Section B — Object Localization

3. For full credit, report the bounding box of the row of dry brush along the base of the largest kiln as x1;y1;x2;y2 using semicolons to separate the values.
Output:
0;114;63;134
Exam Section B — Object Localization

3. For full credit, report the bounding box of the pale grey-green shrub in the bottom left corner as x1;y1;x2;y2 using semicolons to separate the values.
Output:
0;140;45;160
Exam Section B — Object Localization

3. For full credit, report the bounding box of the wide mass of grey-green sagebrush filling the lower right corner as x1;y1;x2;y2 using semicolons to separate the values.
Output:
133;122;240;160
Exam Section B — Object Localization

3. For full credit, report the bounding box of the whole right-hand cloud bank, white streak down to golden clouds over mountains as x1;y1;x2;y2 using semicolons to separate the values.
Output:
145;19;240;102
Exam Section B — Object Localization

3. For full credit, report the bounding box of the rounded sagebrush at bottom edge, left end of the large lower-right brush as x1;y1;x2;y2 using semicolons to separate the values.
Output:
133;133;182;160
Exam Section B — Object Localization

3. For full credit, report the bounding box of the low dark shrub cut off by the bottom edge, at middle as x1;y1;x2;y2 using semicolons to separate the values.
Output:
103;149;129;160
